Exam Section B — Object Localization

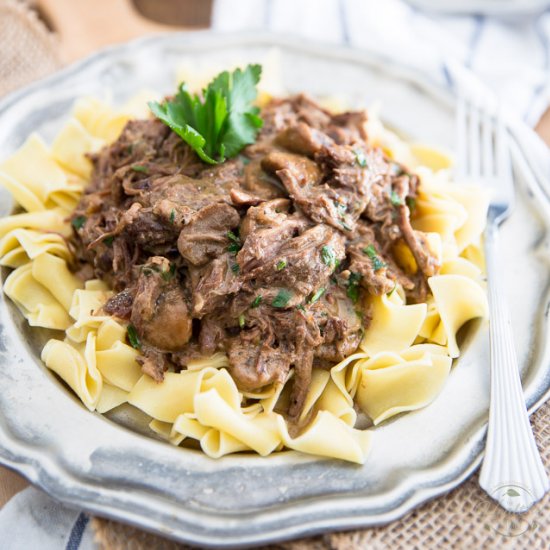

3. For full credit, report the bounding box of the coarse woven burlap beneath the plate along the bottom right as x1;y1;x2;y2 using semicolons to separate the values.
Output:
92;403;550;550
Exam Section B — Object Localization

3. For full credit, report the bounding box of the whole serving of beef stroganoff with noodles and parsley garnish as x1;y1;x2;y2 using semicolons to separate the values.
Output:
0;66;487;463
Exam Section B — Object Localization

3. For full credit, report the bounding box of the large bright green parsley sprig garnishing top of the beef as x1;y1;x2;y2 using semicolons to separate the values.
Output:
149;65;263;164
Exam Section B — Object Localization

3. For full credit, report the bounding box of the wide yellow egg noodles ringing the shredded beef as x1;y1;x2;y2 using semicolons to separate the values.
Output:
0;85;488;463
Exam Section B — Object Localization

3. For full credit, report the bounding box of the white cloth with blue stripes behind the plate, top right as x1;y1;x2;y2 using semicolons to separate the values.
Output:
213;0;550;125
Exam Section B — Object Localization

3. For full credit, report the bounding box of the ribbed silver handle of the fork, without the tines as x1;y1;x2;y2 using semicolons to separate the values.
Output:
479;220;548;512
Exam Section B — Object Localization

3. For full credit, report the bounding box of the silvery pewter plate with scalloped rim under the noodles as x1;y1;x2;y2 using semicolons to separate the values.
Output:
0;33;550;547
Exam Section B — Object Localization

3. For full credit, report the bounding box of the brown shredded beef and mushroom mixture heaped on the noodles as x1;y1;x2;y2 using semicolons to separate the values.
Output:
72;95;439;419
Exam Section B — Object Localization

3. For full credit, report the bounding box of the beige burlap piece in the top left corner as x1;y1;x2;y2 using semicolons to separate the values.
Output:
0;0;61;96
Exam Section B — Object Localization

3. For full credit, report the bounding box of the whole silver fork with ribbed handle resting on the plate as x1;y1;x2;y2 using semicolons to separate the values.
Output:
457;97;548;512
